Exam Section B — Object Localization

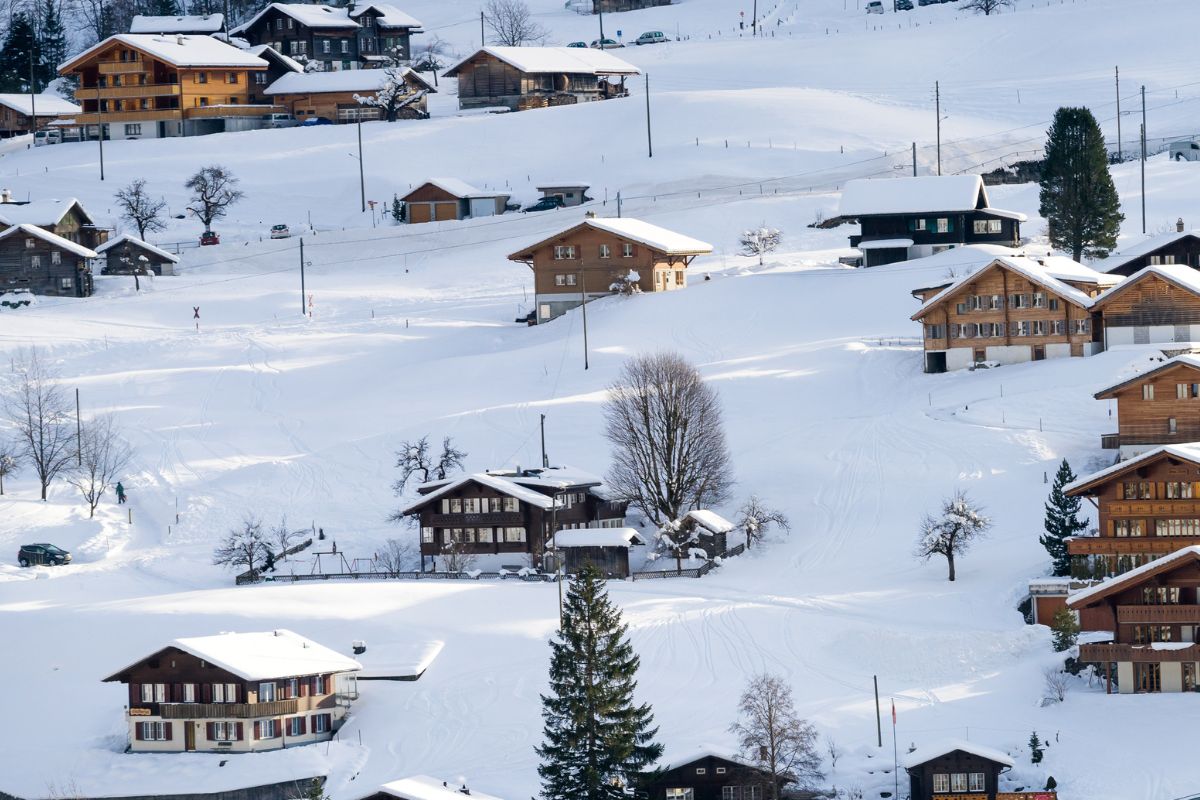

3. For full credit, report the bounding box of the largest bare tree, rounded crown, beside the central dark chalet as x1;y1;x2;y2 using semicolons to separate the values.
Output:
604;353;733;527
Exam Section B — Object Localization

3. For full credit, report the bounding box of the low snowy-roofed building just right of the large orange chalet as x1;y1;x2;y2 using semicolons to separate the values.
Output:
263;67;437;122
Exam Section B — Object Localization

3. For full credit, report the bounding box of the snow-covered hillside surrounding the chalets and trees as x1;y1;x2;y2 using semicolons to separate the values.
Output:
0;0;1200;800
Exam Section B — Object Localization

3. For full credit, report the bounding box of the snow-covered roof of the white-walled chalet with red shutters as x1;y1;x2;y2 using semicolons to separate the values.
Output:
104;628;362;681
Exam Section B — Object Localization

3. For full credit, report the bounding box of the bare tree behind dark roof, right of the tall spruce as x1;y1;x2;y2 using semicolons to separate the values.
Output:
730;673;824;800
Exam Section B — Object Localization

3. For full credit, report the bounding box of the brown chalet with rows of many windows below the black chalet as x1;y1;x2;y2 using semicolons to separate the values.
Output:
912;257;1120;373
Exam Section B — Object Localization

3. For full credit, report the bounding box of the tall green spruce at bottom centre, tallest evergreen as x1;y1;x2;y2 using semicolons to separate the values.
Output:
538;566;662;800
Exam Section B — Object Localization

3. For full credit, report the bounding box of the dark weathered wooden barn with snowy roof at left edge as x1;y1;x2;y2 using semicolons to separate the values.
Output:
0;223;96;297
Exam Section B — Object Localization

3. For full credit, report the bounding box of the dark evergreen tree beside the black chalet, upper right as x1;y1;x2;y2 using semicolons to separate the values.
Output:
1038;108;1124;261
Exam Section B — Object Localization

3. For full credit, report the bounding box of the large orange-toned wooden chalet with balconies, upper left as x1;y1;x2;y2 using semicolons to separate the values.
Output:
59;34;283;139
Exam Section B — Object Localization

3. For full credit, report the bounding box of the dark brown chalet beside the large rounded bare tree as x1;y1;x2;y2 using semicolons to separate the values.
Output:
400;467;628;570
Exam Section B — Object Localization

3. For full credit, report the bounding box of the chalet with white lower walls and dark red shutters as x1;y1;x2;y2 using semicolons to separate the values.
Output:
104;630;360;753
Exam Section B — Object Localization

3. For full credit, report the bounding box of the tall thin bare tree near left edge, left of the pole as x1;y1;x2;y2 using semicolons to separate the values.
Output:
5;350;76;500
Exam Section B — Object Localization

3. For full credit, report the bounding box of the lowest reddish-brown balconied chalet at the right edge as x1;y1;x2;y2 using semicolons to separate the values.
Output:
1067;546;1200;694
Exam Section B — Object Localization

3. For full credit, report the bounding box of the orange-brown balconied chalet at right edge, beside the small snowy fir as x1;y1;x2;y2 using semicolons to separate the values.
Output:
1064;444;1200;578
